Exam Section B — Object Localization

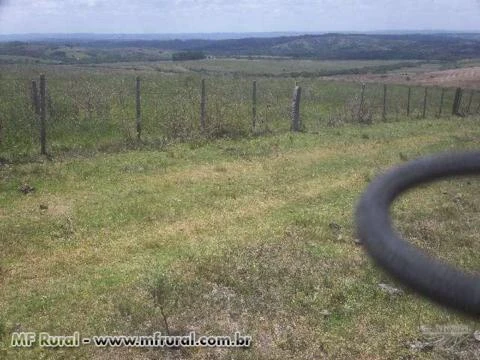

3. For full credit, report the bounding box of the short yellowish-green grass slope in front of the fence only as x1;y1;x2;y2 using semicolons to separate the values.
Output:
0;118;480;359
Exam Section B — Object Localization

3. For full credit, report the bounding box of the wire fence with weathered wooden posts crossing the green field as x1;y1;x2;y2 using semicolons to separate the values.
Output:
0;76;480;159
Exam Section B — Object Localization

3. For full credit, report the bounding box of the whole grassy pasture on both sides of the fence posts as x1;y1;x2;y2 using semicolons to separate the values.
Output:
0;60;480;359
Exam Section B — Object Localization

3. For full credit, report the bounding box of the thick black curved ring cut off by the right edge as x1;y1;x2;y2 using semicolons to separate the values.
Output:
356;152;480;316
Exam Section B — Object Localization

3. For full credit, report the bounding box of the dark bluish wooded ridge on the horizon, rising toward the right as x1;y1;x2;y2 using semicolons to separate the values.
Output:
177;34;480;60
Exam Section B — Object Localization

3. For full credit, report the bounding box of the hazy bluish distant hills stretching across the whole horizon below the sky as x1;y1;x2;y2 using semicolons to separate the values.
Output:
0;33;480;63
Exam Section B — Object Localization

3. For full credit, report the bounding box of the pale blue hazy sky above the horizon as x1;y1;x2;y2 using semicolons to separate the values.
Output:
0;0;480;34
